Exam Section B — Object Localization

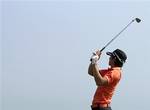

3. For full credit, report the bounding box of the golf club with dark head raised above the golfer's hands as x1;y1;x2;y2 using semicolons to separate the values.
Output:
100;18;141;52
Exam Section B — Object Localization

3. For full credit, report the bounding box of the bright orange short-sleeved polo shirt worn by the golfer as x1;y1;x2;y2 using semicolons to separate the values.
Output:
92;67;121;105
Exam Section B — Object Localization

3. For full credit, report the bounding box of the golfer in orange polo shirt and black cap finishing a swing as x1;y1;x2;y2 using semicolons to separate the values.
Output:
88;49;127;110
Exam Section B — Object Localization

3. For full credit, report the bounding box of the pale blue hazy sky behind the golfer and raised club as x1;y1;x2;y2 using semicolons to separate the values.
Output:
0;0;150;110
